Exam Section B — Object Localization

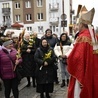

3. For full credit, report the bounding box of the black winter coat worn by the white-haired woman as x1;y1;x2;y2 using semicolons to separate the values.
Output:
21;40;35;77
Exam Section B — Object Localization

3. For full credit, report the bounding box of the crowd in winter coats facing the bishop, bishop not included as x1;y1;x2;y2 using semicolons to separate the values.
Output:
0;29;71;98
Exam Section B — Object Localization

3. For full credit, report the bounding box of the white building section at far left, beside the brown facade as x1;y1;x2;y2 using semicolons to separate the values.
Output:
0;0;13;27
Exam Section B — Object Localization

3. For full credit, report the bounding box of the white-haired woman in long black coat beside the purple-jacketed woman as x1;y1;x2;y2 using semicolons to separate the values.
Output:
21;33;36;87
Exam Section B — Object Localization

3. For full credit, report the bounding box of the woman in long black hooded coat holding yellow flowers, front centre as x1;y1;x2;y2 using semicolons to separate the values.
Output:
34;38;55;98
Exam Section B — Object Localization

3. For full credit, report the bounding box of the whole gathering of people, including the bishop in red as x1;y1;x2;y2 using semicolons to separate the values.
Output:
0;6;98;98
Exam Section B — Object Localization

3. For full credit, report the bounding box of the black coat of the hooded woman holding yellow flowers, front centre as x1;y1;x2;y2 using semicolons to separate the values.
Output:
34;47;56;84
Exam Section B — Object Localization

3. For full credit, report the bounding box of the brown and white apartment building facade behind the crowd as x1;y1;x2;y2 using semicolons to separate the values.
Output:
0;0;72;35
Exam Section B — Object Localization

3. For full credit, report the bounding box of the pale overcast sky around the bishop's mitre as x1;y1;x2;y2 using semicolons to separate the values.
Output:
73;0;98;27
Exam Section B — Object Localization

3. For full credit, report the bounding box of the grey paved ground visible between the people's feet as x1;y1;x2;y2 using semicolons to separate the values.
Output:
0;78;67;98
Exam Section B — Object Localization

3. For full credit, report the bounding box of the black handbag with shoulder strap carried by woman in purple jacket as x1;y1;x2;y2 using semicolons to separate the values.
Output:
2;49;24;81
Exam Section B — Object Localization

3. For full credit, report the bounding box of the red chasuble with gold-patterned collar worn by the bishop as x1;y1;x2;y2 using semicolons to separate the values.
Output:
68;29;98;98
